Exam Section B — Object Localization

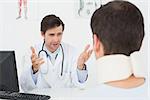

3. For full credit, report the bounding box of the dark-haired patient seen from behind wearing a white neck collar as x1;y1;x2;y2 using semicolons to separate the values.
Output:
81;0;147;97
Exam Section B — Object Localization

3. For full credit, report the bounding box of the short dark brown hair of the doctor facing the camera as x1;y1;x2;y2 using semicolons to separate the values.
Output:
41;14;65;33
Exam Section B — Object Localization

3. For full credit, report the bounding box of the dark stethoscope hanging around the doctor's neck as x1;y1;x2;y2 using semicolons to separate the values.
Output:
38;41;64;76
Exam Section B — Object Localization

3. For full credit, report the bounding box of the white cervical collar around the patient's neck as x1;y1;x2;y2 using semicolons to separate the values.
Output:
96;52;145;83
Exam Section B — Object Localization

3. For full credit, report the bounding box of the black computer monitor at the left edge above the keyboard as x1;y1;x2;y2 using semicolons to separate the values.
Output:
0;51;19;92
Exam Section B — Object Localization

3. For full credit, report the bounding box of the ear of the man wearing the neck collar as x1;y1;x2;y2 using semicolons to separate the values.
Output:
93;34;104;59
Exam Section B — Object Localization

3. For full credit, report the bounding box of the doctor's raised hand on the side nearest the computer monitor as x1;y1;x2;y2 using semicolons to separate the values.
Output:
31;46;44;74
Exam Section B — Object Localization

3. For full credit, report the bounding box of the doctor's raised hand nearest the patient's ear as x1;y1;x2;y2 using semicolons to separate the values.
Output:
77;44;93;70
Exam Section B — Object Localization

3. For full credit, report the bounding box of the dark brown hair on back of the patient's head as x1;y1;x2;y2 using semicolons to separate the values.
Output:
91;0;145;56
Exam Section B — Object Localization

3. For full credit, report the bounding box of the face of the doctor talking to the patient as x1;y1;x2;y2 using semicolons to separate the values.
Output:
42;25;63;52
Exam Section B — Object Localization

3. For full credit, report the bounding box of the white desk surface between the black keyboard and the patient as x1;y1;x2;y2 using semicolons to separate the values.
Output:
31;88;87;100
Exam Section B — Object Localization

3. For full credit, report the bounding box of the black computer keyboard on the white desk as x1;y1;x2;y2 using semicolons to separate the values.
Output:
0;91;50;100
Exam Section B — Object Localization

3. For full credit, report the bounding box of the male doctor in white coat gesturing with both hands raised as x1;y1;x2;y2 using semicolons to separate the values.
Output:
20;15;92;92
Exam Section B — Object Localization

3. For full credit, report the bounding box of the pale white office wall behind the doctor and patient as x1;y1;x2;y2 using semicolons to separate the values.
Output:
0;0;150;99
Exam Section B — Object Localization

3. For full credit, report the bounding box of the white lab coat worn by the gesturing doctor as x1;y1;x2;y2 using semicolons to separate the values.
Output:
20;43;87;92
